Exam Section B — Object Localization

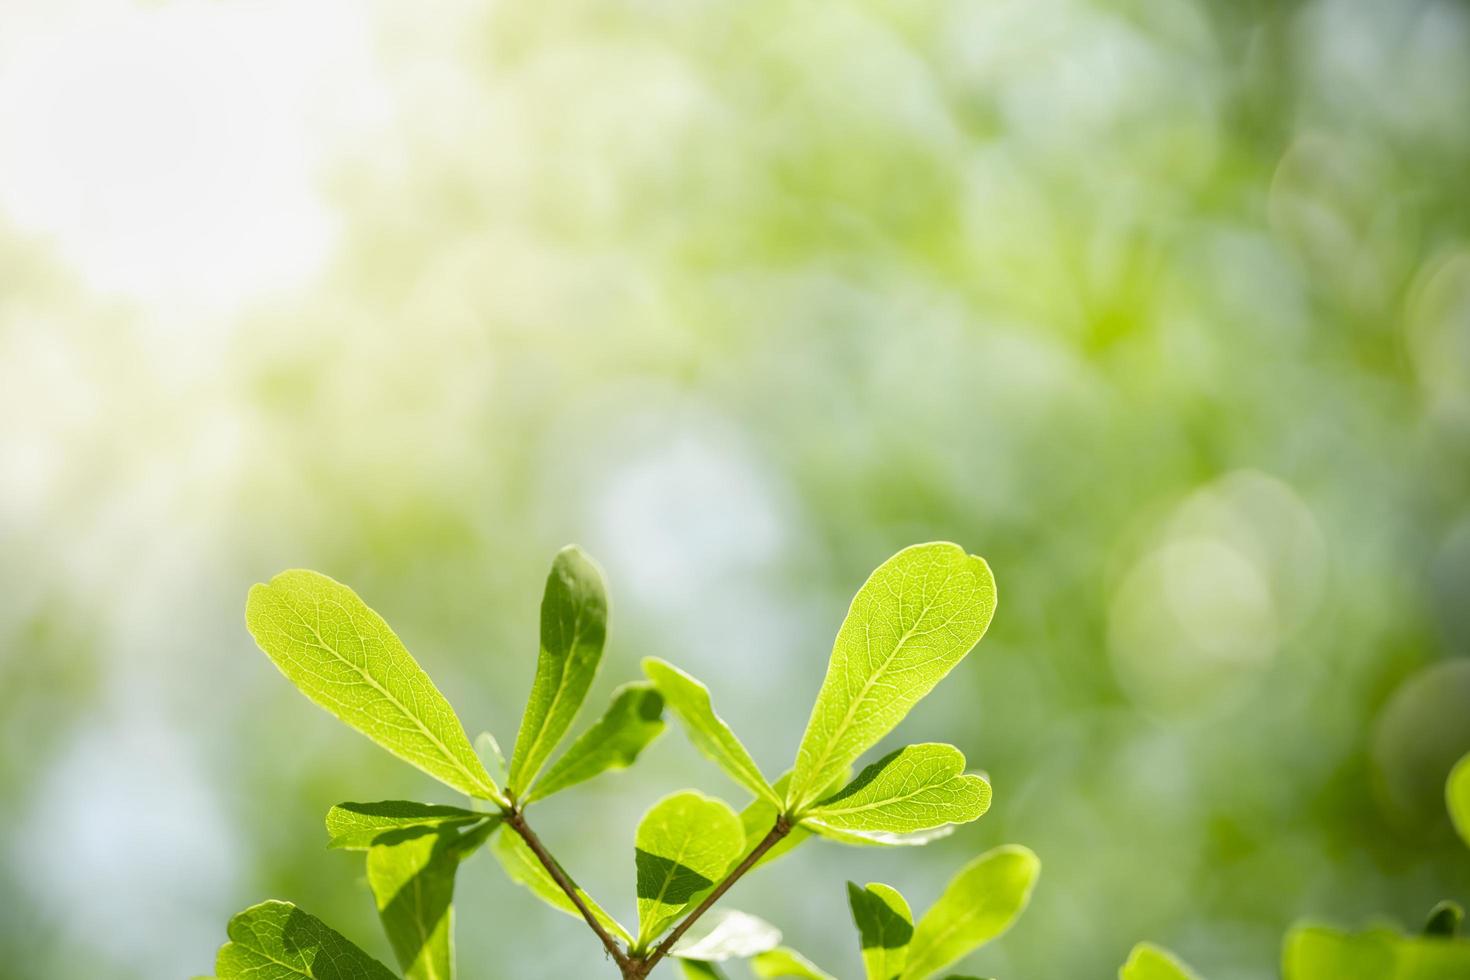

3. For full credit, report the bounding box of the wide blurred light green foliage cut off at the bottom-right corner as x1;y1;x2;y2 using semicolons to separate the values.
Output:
1282;926;1470;980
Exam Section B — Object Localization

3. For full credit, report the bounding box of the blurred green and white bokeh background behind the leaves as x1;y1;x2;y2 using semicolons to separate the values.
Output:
0;0;1470;980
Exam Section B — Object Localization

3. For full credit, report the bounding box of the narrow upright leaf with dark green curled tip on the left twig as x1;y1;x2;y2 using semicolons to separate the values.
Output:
507;545;607;796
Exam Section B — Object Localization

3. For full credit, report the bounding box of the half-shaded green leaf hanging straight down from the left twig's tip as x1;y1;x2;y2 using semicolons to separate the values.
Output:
368;821;498;980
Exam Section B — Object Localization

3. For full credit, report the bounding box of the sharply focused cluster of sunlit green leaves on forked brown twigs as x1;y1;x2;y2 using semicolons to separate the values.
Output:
215;542;1039;980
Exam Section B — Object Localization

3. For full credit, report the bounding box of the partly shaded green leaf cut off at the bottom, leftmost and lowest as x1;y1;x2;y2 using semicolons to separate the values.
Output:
215;902;392;980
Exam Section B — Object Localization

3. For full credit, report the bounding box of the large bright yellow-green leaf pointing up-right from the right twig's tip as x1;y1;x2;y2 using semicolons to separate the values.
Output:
786;542;995;814
